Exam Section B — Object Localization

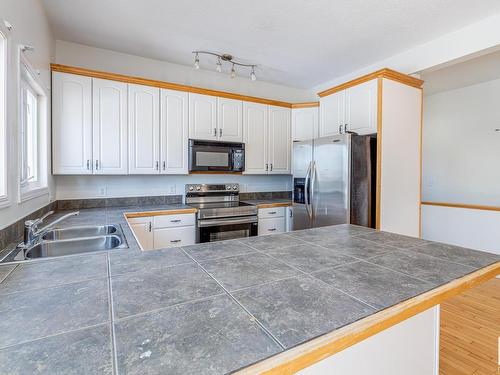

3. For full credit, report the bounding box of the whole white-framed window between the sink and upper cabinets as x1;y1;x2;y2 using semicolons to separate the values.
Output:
19;50;48;201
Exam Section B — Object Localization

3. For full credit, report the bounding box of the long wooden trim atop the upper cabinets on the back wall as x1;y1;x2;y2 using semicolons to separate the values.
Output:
50;64;292;108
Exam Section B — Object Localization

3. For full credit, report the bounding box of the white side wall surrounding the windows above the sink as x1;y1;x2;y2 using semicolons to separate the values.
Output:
0;0;55;229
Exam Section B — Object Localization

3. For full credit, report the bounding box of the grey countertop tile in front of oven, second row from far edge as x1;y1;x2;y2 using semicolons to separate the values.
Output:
200;253;299;290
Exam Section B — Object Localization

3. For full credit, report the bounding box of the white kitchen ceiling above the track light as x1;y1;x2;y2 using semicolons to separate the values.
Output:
42;0;500;88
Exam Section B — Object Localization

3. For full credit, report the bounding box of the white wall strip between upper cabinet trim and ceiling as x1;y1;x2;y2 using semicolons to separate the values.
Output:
56;40;316;103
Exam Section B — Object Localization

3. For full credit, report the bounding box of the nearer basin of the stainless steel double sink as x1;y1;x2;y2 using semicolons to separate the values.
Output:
24;234;124;260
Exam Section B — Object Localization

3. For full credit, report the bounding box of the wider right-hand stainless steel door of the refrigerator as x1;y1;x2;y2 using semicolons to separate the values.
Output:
311;134;351;227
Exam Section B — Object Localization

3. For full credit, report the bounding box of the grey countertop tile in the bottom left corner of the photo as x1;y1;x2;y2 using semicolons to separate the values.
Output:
0;324;113;375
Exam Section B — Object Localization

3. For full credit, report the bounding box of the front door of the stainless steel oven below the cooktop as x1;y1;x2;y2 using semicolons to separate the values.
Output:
197;216;258;242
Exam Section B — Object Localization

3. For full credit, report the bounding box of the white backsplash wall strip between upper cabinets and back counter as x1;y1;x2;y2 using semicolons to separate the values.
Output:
56;174;292;199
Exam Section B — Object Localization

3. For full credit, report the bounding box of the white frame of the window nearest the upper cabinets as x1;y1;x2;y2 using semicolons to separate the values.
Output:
18;50;49;203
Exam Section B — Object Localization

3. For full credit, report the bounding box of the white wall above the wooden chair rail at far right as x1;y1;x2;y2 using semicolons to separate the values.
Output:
422;78;500;206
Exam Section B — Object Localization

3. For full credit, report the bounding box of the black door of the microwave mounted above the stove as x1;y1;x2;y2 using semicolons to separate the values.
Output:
189;145;233;171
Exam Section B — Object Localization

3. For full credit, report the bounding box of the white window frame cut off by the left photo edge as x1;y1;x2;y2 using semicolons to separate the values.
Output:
0;25;11;208
